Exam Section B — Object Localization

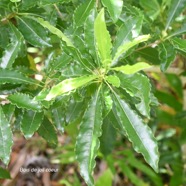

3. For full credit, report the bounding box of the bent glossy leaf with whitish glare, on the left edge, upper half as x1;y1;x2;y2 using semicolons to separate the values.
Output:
0;23;24;69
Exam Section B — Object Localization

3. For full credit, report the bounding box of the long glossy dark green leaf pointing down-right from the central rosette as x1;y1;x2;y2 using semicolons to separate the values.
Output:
112;91;159;172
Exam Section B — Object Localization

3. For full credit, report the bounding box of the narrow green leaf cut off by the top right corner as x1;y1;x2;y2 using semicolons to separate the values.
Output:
165;0;186;30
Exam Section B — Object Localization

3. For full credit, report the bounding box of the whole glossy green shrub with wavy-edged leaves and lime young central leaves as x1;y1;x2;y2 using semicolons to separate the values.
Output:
0;0;186;185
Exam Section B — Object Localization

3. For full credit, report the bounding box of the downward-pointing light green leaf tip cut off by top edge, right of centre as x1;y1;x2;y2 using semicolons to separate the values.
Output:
102;0;123;22
